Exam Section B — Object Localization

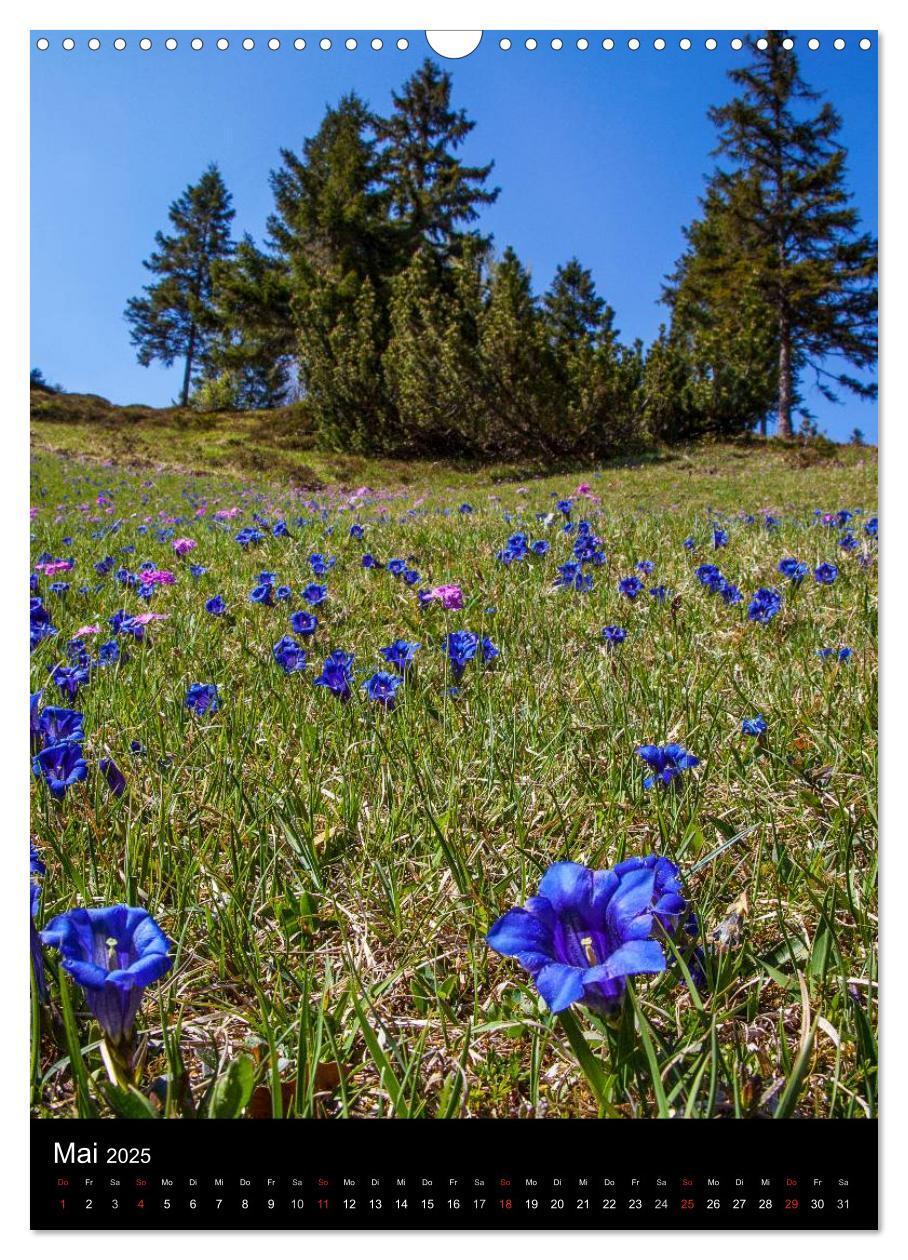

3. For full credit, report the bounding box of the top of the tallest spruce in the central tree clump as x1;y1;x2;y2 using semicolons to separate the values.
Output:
374;58;499;258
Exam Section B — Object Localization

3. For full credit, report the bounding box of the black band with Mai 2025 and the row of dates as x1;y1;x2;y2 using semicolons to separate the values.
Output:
31;1120;878;1230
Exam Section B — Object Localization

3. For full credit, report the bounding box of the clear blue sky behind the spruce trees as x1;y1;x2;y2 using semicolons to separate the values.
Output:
31;32;878;441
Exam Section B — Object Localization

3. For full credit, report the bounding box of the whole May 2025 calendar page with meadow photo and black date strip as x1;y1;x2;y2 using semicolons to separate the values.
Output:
30;24;878;1231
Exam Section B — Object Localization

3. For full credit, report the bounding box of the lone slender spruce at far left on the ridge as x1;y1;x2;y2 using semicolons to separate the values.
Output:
126;164;236;407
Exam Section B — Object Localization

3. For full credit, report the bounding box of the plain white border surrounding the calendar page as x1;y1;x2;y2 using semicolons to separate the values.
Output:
0;0;908;1260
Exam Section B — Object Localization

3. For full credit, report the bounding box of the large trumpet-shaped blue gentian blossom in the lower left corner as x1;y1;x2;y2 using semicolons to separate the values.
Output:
42;906;173;1046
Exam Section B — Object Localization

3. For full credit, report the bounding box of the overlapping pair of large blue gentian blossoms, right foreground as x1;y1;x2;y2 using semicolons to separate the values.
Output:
486;854;688;1013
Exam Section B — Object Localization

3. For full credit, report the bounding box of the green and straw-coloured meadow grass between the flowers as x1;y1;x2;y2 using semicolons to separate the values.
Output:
31;435;877;1118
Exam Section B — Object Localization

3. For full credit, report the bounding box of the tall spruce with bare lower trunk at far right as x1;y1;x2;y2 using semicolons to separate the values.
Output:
675;32;877;437
